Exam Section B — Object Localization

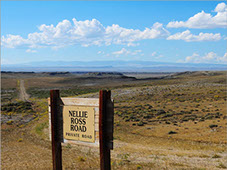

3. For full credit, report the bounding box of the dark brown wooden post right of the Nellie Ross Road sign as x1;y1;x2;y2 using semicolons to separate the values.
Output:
99;90;113;170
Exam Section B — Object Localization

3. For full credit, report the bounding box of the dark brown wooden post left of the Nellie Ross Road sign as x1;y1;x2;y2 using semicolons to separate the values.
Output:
50;90;62;170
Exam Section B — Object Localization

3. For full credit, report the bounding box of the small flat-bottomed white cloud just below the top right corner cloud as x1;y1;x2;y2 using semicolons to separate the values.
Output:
167;30;221;42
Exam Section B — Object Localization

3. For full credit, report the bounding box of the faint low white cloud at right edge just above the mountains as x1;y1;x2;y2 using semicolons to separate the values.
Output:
181;52;227;64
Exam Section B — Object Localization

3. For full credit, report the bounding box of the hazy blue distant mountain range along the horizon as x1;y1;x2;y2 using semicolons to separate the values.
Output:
1;60;227;72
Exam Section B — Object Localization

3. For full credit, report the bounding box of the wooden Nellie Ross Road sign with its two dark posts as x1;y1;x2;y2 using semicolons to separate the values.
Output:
49;90;114;170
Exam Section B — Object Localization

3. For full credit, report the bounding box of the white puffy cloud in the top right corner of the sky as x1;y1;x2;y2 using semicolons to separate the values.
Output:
167;2;227;28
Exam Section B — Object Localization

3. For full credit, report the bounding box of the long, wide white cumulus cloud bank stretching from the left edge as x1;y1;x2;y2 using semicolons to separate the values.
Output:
2;18;169;48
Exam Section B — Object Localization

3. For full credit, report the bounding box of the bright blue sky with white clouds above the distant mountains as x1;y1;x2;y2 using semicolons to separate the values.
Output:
1;1;227;64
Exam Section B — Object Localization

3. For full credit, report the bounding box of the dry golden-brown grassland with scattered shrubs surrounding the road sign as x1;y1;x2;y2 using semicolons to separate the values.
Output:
1;72;227;170
